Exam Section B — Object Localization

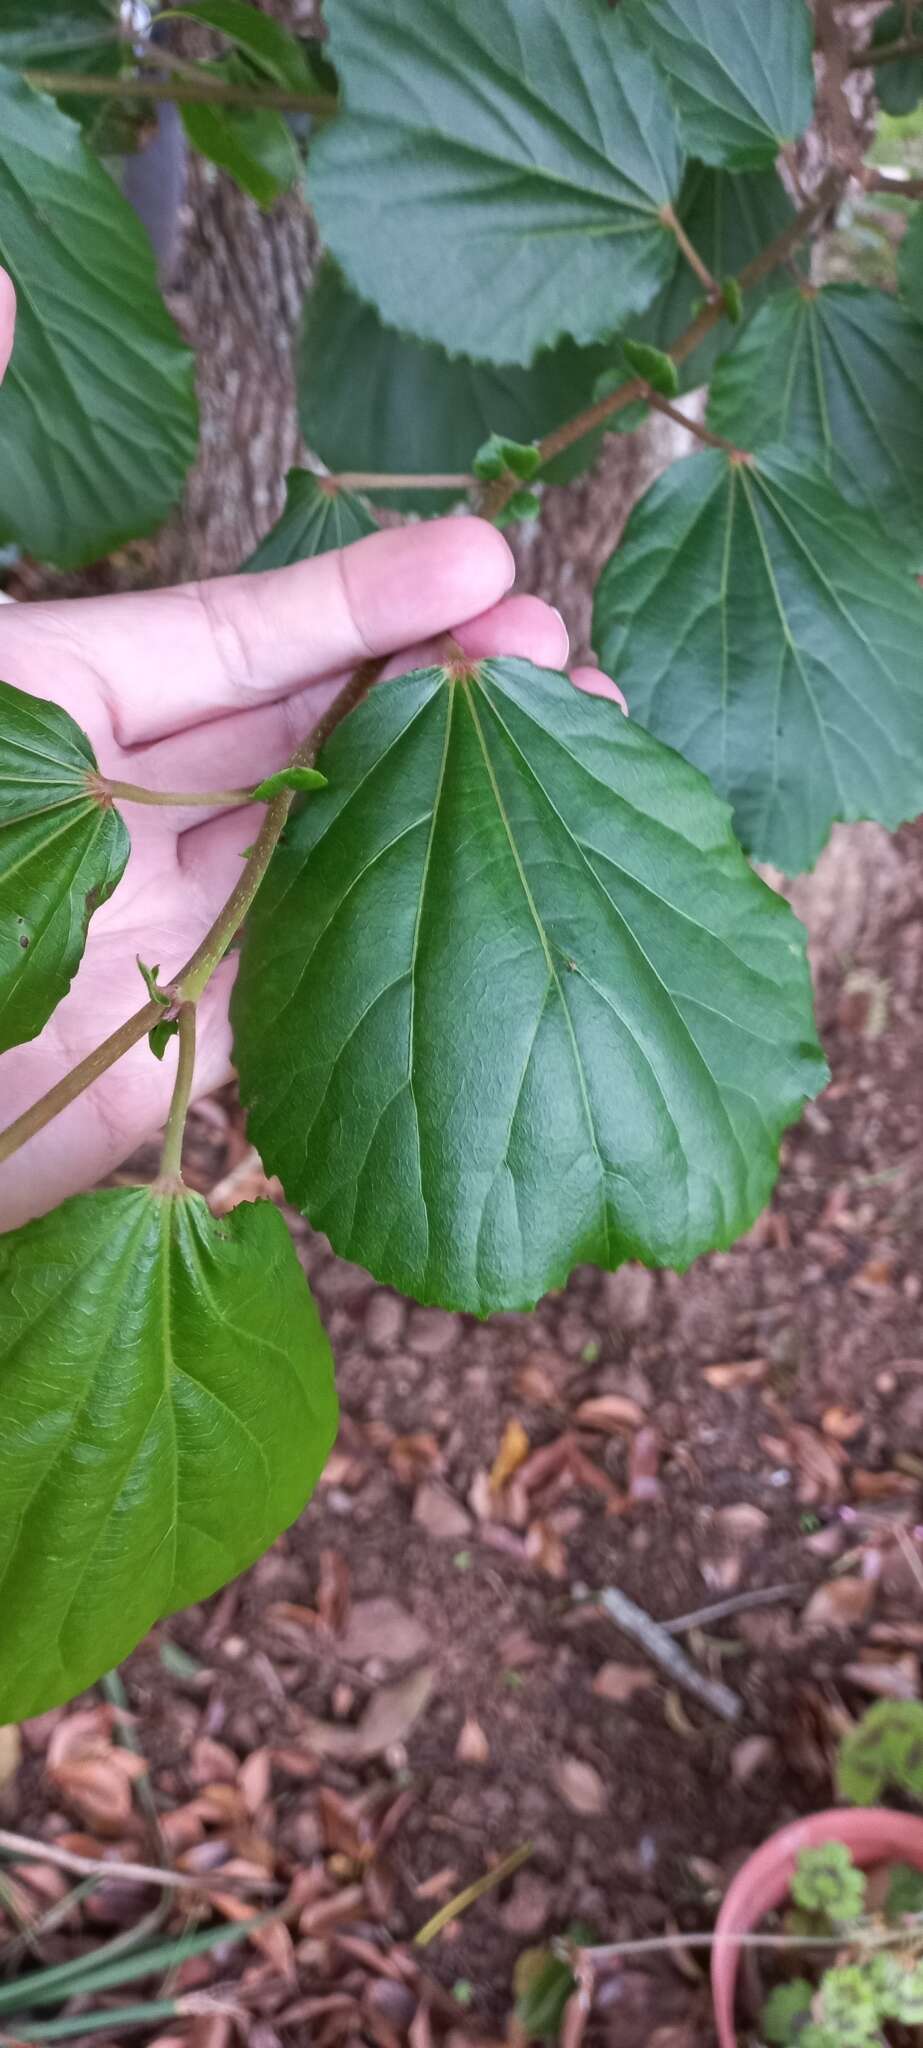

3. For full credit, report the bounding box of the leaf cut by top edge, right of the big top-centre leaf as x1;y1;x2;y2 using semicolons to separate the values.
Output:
622;0;815;170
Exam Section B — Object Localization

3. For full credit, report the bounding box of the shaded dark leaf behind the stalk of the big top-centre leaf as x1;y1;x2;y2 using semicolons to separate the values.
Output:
632;164;794;389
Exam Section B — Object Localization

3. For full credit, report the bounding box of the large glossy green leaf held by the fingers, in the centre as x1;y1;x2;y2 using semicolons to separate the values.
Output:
235;662;825;1315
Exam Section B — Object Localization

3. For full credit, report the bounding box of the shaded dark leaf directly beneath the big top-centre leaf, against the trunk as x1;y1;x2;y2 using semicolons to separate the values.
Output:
299;258;612;514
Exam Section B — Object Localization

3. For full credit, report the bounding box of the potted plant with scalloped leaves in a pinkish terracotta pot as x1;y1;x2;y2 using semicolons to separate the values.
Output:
712;1700;923;2048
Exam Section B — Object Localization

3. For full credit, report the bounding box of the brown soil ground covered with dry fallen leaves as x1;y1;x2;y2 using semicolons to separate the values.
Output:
0;827;923;2048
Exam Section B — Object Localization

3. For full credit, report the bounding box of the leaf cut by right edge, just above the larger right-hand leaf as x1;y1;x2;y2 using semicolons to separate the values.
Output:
708;285;923;537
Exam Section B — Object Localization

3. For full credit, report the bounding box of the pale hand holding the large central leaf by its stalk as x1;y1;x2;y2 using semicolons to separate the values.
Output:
0;501;618;1229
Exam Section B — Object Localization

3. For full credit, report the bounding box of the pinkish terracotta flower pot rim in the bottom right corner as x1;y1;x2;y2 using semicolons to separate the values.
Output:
712;1806;923;2048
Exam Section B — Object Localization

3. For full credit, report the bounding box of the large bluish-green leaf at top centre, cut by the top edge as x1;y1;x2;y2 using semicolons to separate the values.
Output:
309;0;682;362
